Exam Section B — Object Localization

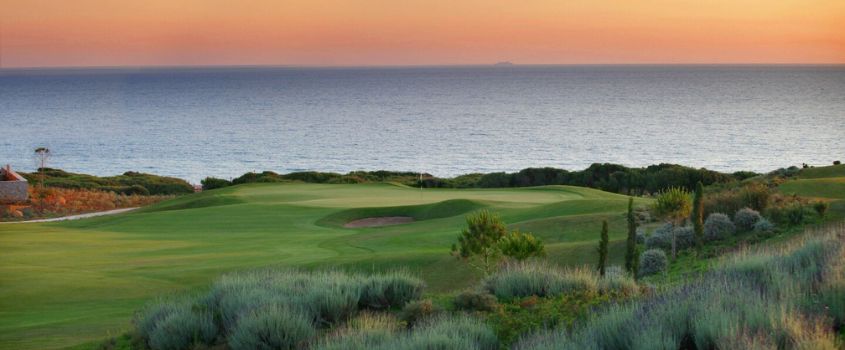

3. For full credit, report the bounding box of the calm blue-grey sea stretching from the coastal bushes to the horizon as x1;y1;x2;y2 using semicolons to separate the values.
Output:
0;66;845;182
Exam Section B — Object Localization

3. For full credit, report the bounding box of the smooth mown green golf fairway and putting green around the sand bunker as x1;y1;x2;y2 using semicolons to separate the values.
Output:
0;184;647;349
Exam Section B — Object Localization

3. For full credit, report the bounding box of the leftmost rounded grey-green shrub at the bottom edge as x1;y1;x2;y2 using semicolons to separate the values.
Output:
149;307;217;350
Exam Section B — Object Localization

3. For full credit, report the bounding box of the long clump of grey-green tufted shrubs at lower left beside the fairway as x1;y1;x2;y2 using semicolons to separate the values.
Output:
135;269;424;350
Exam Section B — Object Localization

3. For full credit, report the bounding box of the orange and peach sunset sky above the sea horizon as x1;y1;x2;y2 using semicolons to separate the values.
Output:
0;0;845;68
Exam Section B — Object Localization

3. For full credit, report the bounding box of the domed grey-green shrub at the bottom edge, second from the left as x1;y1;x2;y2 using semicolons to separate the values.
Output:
229;305;316;350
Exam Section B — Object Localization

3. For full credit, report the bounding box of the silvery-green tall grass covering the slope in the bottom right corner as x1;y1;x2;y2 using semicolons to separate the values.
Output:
517;226;845;349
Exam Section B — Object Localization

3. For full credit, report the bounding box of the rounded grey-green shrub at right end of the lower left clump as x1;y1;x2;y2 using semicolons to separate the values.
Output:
359;270;425;309
